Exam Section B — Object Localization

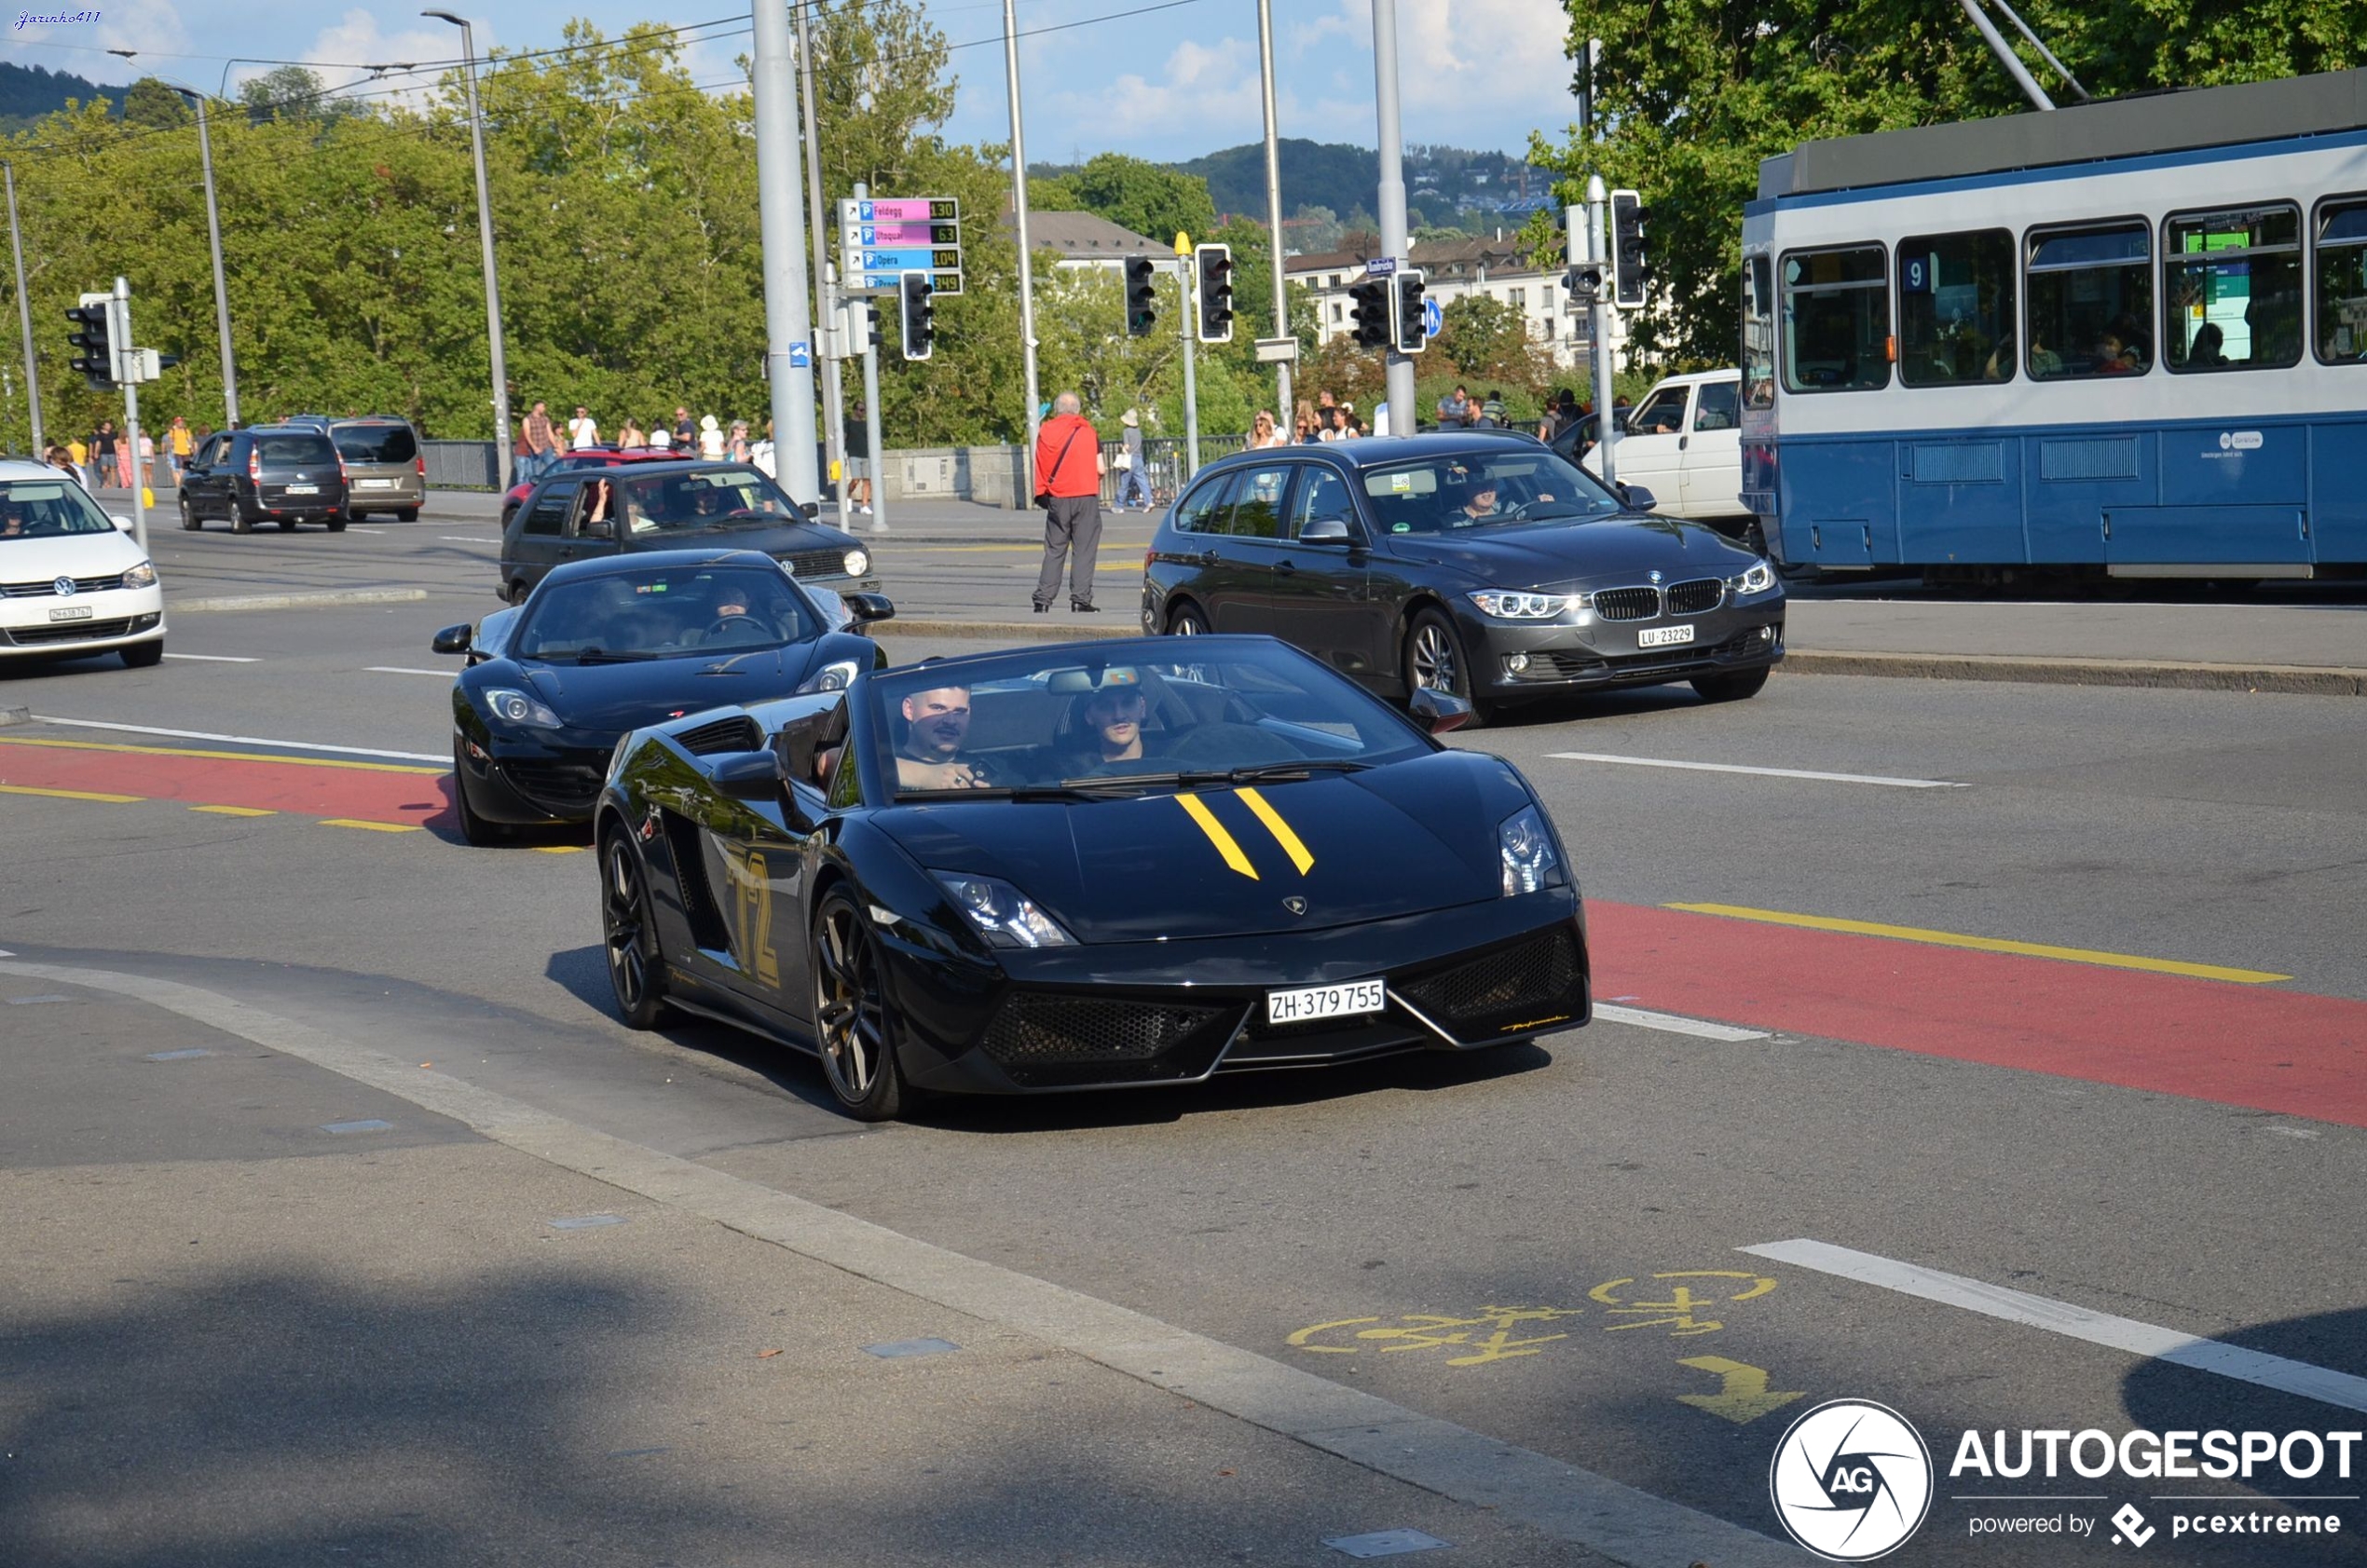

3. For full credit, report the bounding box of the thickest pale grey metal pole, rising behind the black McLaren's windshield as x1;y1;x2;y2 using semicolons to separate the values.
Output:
755;0;821;504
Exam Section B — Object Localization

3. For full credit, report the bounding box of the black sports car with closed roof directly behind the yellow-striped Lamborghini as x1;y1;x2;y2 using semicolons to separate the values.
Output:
433;551;895;844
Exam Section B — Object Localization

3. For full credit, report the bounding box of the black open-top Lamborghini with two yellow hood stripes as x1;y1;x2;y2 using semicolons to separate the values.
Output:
595;636;1591;1119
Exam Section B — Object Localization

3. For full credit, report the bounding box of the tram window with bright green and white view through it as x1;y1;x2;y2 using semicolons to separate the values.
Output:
2161;206;2301;372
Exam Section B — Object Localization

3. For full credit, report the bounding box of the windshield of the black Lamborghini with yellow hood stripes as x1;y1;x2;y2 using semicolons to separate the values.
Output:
867;638;1430;799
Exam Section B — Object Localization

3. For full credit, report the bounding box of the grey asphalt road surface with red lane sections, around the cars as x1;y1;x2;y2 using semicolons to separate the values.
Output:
0;508;2367;1568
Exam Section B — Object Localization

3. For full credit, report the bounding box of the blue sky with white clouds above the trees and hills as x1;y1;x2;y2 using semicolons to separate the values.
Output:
5;0;1572;163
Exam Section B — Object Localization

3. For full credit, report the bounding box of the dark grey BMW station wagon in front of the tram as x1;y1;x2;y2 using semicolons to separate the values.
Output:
1143;430;1785;719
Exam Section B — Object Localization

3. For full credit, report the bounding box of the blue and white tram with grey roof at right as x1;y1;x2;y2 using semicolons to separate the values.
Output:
1742;71;2367;579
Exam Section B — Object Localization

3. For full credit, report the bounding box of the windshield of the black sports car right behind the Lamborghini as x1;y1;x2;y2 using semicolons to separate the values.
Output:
509;566;824;664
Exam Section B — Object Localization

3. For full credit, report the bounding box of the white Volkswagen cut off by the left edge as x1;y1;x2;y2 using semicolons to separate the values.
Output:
0;461;163;669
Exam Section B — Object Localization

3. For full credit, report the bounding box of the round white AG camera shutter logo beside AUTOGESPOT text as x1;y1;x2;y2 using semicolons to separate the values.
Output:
1768;1400;1932;1563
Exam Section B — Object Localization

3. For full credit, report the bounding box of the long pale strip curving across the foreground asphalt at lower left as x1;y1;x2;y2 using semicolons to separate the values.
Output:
0;962;1799;1568
